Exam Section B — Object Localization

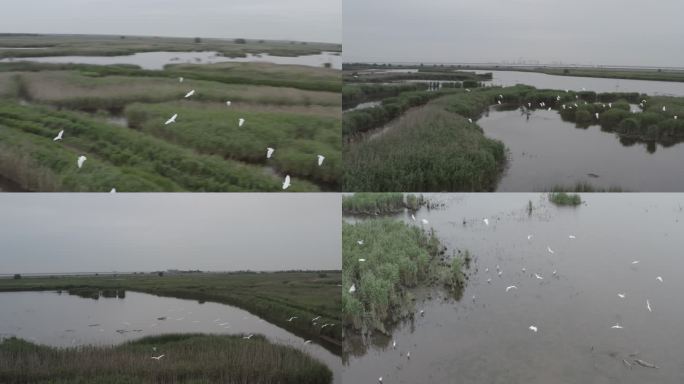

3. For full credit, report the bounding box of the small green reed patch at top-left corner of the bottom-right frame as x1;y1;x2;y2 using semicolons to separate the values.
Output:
342;192;427;215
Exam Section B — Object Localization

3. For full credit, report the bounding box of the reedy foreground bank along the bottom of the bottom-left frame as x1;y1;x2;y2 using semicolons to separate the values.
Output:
0;334;332;384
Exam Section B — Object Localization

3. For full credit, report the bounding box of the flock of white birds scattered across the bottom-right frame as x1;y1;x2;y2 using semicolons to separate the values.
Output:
349;214;664;383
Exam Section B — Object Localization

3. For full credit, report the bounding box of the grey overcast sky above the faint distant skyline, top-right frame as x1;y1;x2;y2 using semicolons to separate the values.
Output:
343;0;684;67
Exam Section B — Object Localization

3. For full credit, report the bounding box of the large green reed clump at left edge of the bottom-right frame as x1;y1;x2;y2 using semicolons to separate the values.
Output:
342;219;469;333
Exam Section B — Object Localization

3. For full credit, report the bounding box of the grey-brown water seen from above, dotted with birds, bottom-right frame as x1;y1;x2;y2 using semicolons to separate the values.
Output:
343;193;684;384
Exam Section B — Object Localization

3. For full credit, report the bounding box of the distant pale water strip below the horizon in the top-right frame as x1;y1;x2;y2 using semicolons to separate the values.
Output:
485;71;684;96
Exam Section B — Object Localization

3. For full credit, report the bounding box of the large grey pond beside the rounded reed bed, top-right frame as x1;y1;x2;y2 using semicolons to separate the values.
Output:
477;106;684;192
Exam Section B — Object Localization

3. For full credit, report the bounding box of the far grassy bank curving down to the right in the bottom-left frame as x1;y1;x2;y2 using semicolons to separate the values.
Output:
0;271;342;354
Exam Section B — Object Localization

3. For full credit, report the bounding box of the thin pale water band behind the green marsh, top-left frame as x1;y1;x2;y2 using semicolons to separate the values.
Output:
0;51;342;70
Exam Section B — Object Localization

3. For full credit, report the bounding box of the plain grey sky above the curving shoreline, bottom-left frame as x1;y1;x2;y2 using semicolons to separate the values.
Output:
0;193;342;274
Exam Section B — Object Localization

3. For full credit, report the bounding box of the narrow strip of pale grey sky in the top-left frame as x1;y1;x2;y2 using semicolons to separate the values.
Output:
0;0;342;44
